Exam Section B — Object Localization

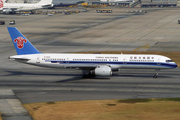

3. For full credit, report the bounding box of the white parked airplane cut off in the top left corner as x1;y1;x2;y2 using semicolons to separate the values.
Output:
0;0;53;14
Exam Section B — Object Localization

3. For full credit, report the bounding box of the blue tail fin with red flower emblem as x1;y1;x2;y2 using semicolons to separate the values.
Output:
7;27;40;55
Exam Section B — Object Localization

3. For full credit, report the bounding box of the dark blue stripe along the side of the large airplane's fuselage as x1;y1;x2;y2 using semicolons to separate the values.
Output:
46;60;177;68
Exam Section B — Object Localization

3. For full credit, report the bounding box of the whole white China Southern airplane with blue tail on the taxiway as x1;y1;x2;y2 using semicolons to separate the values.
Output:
7;27;177;78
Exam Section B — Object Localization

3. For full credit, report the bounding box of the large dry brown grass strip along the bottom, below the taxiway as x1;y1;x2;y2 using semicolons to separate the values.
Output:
24;98;180;120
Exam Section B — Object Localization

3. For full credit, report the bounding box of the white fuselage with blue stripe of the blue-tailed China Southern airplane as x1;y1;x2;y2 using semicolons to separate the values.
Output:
10;53;177;70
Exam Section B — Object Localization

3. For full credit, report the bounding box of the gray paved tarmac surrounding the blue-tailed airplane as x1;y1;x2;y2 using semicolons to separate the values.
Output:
0;8;180;120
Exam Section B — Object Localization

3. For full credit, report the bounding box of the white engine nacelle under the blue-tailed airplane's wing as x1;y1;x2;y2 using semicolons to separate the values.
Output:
94;65;112;76
